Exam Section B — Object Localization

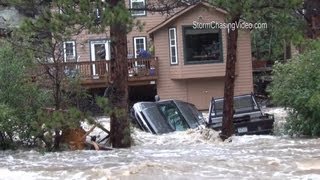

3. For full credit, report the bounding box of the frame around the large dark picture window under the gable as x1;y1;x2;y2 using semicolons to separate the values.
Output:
182;25;224;65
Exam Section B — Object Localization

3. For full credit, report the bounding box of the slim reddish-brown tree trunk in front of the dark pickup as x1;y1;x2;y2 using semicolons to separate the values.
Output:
220;17;239;140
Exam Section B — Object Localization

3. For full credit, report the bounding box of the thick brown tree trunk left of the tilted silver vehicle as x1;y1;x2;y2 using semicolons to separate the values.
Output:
110;0;131;148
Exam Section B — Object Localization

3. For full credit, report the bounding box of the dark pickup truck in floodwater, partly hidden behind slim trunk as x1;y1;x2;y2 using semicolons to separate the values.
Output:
207;94;274;135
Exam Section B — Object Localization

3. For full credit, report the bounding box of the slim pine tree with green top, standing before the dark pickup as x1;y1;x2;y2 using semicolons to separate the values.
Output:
209;0;302;140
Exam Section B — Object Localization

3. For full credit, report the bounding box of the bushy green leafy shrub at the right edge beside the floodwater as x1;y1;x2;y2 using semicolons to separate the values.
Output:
269;43;320;136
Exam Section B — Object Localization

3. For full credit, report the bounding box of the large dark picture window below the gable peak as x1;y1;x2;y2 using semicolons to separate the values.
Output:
184;27;223;64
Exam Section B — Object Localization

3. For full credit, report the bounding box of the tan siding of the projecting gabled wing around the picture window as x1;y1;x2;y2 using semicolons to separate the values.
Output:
153;3;253;110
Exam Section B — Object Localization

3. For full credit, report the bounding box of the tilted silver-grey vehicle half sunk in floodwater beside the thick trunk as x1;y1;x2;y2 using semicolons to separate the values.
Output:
130;100;205;134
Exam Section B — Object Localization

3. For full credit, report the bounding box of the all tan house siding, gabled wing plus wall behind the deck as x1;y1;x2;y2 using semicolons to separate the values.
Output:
67;0;253;110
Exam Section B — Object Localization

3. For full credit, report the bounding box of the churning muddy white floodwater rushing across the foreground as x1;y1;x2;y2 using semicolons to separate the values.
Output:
0;109;320;180
